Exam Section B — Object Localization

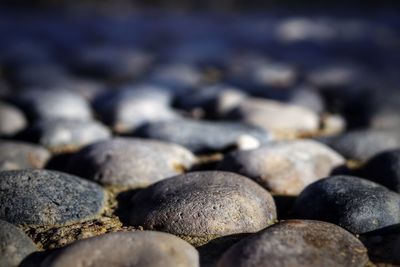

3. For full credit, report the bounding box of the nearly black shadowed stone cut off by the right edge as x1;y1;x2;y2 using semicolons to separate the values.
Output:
360;149;400;193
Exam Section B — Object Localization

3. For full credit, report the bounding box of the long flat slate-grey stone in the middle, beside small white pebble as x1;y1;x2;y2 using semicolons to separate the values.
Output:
136;119;272;153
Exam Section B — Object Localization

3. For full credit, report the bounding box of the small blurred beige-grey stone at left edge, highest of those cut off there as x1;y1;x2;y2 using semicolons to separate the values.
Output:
0;102;28;136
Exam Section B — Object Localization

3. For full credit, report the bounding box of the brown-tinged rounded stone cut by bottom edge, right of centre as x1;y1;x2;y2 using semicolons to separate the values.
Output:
218;220;369;267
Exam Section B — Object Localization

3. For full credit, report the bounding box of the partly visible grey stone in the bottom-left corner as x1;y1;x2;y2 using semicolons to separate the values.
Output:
0;220;37;267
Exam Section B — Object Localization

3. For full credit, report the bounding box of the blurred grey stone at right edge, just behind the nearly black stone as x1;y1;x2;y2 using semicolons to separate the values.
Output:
317;129;400;162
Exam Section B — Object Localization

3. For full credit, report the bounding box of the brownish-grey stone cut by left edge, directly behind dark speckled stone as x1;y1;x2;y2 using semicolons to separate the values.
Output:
0;140;51;170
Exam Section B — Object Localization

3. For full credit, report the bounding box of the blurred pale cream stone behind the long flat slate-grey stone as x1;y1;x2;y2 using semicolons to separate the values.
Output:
229;98;319;136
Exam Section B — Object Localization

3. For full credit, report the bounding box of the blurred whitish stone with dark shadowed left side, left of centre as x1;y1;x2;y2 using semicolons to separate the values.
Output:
94;85;180;133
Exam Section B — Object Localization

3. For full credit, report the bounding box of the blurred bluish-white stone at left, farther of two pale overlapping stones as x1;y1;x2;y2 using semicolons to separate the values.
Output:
13;88;92;120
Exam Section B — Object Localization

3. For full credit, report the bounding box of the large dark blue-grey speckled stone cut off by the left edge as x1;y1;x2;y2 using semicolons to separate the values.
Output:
0;170;105;226
